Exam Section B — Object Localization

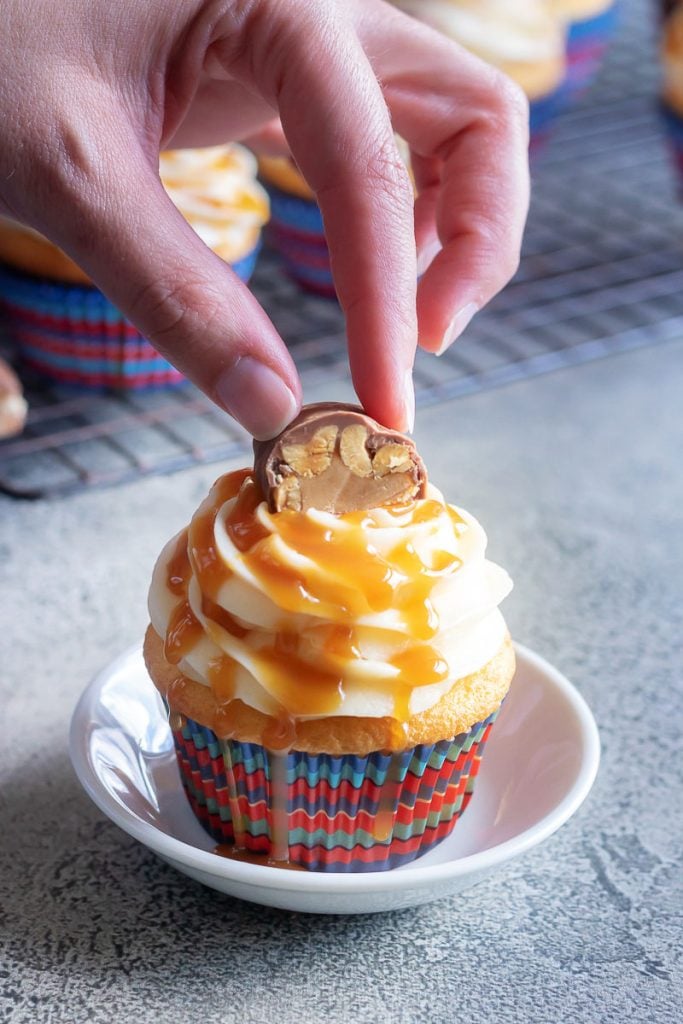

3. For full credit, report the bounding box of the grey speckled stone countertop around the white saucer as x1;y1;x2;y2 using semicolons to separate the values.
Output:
0;343;683;1024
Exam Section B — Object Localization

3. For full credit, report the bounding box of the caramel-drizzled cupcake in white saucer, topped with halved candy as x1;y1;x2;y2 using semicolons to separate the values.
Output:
144;404;514;871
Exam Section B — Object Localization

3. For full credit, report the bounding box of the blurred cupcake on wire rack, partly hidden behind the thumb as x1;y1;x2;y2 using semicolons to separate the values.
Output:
0;145;268;390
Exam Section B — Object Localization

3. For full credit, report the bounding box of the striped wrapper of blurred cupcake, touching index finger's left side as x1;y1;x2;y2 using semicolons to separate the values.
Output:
263;181;336;298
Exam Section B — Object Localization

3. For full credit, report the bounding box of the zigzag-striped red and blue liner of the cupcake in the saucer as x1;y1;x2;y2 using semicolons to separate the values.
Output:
167;712;498;871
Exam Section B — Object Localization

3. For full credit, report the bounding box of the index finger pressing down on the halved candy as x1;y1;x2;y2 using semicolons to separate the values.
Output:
215;2;417;430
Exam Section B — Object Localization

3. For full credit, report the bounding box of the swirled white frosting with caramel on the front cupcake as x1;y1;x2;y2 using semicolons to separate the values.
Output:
150;471;512;719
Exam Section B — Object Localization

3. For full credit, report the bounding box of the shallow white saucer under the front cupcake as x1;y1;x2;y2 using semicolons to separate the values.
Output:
70;645;600;913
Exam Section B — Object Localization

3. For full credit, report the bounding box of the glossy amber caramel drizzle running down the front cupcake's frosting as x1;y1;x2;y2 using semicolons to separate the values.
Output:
165;470;463;724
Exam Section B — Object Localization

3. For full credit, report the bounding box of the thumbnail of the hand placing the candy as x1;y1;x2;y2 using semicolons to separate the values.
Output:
215;355;299;441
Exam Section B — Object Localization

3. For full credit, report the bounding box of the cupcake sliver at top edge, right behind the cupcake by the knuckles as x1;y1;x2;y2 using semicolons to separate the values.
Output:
546;0;616;101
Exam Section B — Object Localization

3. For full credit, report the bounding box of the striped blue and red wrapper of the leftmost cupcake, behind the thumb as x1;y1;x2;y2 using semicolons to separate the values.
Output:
0;247;258;391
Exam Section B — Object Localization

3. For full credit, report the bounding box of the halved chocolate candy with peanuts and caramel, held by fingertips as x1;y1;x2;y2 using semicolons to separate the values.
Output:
254;402;427;514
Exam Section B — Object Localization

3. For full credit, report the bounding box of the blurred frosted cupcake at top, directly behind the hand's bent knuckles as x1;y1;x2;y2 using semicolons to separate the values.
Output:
392;0;565;147
